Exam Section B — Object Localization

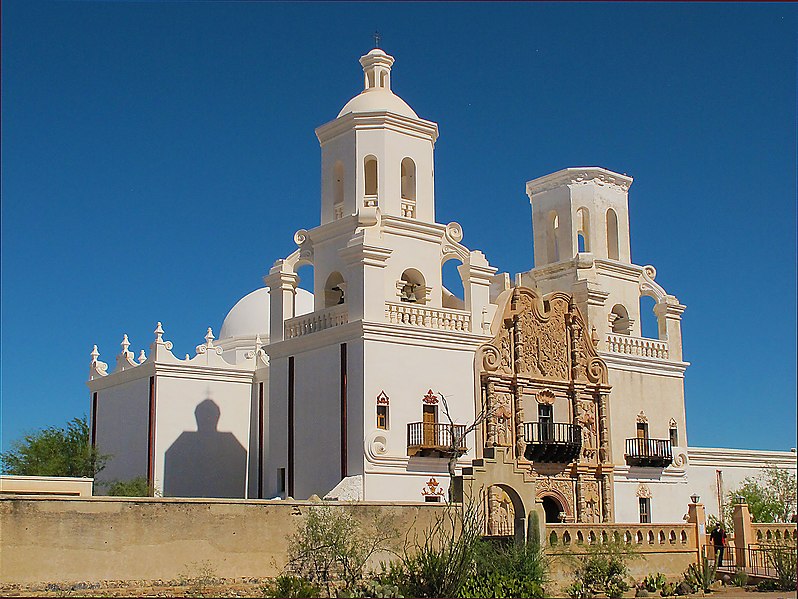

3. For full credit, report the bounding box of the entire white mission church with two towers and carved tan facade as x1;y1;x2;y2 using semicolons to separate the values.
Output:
88;49;796;534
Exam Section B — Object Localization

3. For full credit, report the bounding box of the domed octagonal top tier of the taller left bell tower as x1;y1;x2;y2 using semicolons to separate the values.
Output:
316;48;438;224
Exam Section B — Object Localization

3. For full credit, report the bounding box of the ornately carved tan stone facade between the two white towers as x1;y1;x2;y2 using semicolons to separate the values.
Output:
477;287;613;526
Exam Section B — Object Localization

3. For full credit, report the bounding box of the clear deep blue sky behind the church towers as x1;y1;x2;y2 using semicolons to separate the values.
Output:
2;0;798;449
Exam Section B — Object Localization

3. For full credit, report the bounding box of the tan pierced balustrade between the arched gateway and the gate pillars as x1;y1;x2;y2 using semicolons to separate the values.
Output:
546;523;697;553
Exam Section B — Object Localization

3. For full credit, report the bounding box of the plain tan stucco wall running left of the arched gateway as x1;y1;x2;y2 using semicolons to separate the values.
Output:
0;497;445;584
